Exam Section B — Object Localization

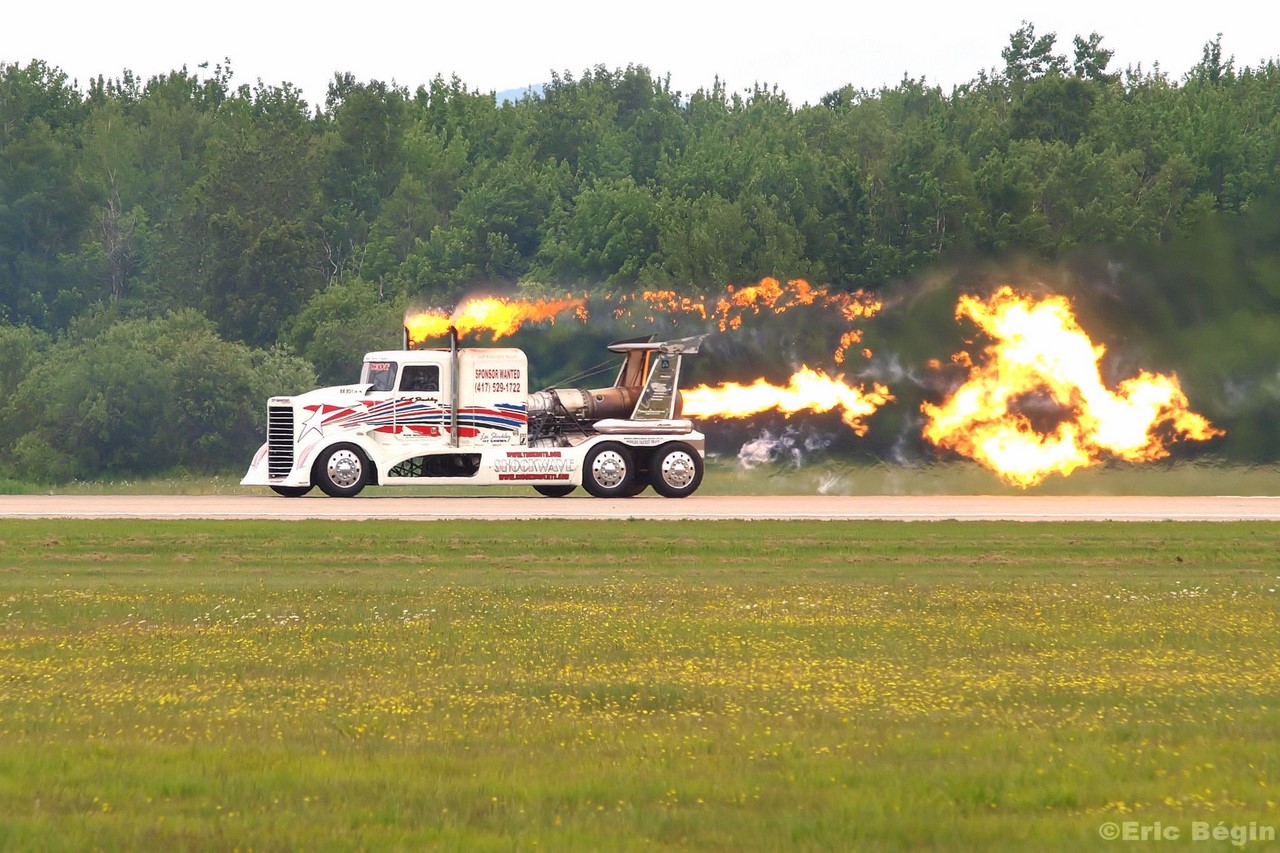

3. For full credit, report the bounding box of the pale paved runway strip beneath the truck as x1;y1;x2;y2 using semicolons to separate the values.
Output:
0;494;1280;521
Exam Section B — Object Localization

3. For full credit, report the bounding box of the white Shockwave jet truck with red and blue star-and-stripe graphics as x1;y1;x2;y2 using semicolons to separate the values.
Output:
241;330;705;498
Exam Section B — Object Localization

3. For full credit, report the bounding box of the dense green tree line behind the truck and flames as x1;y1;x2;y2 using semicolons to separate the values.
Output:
0;23;1280;479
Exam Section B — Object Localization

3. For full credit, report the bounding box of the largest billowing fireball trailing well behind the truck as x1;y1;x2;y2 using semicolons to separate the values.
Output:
922;287;1222;488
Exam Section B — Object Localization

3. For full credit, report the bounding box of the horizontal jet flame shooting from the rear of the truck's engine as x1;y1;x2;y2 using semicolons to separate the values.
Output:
681;366;893;435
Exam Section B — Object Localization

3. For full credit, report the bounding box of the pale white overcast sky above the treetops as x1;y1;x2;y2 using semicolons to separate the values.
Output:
0;0;1280;106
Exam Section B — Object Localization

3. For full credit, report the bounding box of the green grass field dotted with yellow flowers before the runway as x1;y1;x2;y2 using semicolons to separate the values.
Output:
0;521;1280;850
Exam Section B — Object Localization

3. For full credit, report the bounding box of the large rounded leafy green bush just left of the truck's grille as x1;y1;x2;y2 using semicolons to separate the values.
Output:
13;311;310;480
